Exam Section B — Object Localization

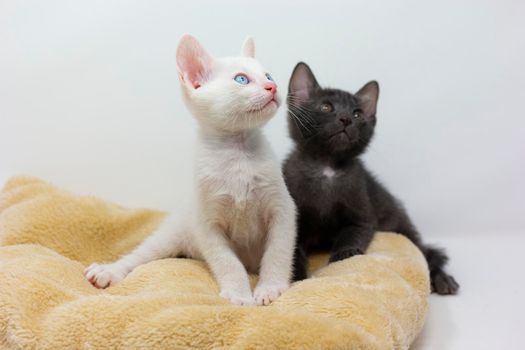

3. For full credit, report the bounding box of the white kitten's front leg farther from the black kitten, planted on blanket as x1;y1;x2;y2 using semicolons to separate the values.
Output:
197;227;255;305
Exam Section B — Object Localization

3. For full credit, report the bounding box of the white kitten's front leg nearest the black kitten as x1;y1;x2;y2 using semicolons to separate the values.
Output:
254;197;296;305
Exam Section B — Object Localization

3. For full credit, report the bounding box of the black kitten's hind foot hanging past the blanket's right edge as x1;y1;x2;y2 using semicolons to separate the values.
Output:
422;246;459;295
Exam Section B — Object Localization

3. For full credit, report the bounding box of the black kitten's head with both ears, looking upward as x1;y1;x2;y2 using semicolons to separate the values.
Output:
288;63;379;158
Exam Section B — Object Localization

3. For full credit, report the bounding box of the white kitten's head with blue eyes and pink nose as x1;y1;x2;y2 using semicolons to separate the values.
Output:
177;35;281;132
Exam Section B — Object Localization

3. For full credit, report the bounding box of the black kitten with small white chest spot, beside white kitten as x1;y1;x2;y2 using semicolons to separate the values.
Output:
284;62;459;294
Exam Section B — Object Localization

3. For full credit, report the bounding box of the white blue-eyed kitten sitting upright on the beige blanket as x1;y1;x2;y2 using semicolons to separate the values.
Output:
85;35;296;305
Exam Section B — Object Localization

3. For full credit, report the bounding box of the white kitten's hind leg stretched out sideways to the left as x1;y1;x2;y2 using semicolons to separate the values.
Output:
84;216;183;288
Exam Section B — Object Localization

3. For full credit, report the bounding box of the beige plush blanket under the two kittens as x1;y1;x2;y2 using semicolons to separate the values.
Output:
0;177;429;350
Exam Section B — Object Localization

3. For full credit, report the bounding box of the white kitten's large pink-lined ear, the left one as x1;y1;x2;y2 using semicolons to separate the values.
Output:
177;34;213;89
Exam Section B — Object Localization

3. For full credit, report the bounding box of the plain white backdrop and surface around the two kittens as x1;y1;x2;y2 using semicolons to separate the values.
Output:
0;0;525;349
